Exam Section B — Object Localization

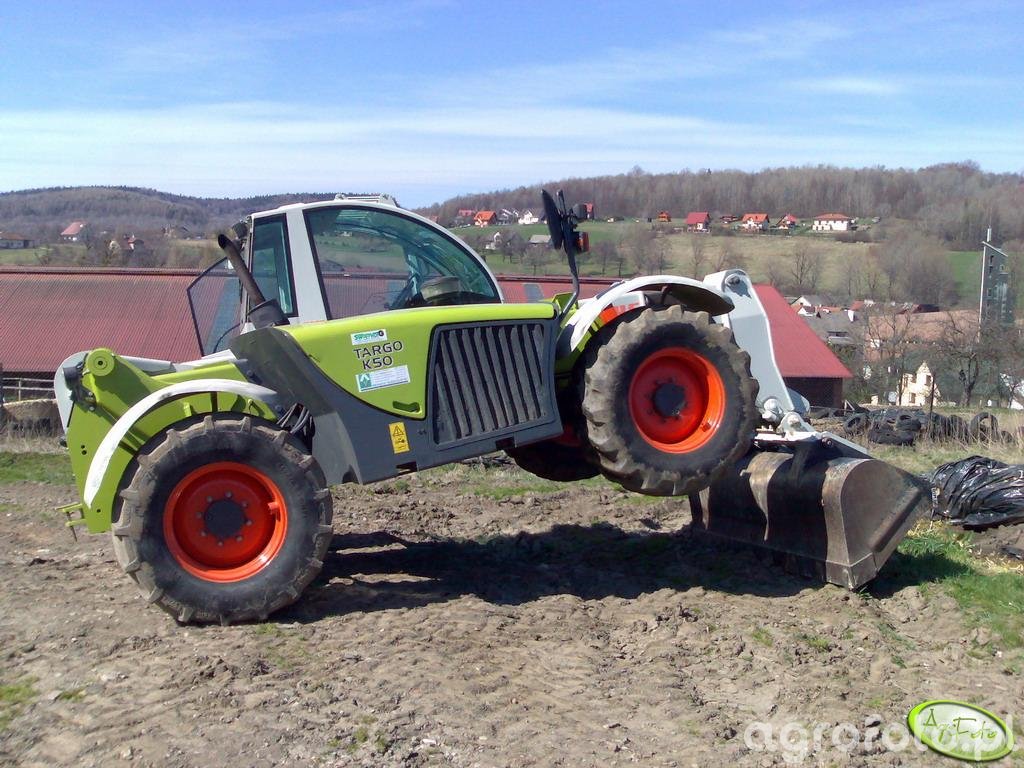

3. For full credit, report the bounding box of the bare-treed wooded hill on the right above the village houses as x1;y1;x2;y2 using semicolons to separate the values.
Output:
422;162;1024;249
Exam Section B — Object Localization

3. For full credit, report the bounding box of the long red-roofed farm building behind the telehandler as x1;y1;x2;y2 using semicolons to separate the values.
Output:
0;267;850;406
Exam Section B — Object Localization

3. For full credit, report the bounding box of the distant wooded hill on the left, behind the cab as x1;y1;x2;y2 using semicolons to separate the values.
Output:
0;186;334;242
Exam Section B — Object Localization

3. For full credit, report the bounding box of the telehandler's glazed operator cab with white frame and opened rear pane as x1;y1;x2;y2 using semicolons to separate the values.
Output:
188;199;502;354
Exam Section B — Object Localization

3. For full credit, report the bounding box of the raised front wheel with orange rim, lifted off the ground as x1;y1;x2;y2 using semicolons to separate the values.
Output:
581;306;759;496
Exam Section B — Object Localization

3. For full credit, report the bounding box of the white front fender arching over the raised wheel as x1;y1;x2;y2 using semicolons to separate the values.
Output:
558;274;733;357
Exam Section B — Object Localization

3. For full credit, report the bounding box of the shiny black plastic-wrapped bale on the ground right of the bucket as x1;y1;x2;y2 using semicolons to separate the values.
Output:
932;456;1024;528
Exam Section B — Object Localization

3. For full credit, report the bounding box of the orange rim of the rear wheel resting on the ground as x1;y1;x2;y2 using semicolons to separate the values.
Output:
164;462;288;582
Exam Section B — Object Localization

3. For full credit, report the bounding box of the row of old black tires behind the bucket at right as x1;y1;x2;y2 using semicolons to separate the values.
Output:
843;408;1014;445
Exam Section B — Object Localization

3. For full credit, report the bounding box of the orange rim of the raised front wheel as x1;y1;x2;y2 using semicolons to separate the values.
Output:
629;347;726;454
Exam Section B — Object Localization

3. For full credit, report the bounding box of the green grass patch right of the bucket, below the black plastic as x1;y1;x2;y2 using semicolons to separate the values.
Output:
894;523;1024;648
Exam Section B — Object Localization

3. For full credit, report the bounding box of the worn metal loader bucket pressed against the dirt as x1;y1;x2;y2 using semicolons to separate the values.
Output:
690;433;928;589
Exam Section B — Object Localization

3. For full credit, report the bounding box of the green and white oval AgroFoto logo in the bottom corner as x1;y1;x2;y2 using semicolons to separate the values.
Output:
906;700;1014;761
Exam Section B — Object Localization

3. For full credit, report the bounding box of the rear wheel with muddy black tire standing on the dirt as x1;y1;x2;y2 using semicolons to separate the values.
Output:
112;415;333;624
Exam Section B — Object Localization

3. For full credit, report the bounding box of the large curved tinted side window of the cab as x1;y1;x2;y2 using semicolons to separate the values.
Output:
305;207;500;317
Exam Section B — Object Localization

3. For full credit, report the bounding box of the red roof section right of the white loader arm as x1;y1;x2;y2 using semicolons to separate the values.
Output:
754;286;853;379
